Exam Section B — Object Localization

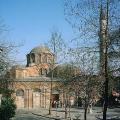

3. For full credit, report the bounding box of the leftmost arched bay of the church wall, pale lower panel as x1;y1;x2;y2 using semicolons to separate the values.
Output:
16;89;24;108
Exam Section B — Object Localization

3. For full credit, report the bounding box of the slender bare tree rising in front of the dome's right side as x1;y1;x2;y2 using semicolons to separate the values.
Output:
48;31;65;114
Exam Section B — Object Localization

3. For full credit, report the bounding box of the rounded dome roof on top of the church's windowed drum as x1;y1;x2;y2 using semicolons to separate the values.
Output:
30;46;51;54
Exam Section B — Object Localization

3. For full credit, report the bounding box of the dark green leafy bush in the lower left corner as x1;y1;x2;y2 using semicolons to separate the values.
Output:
0;97;16;120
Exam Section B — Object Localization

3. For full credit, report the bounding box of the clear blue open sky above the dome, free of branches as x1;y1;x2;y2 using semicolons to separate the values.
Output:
0;0;73;63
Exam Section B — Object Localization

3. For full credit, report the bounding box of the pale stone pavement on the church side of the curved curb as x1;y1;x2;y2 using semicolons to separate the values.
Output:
14;107;120;120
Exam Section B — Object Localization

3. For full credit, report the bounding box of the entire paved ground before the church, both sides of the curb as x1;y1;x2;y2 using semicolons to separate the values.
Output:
12;107;120;120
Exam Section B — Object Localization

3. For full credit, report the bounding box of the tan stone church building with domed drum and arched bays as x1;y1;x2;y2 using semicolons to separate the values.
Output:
10;46;64;109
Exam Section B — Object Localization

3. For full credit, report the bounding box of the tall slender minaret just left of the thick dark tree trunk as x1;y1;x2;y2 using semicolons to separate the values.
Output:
99;5;107;75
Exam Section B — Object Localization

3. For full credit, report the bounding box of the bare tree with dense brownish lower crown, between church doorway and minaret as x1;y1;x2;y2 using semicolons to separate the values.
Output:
68;48;102;120
